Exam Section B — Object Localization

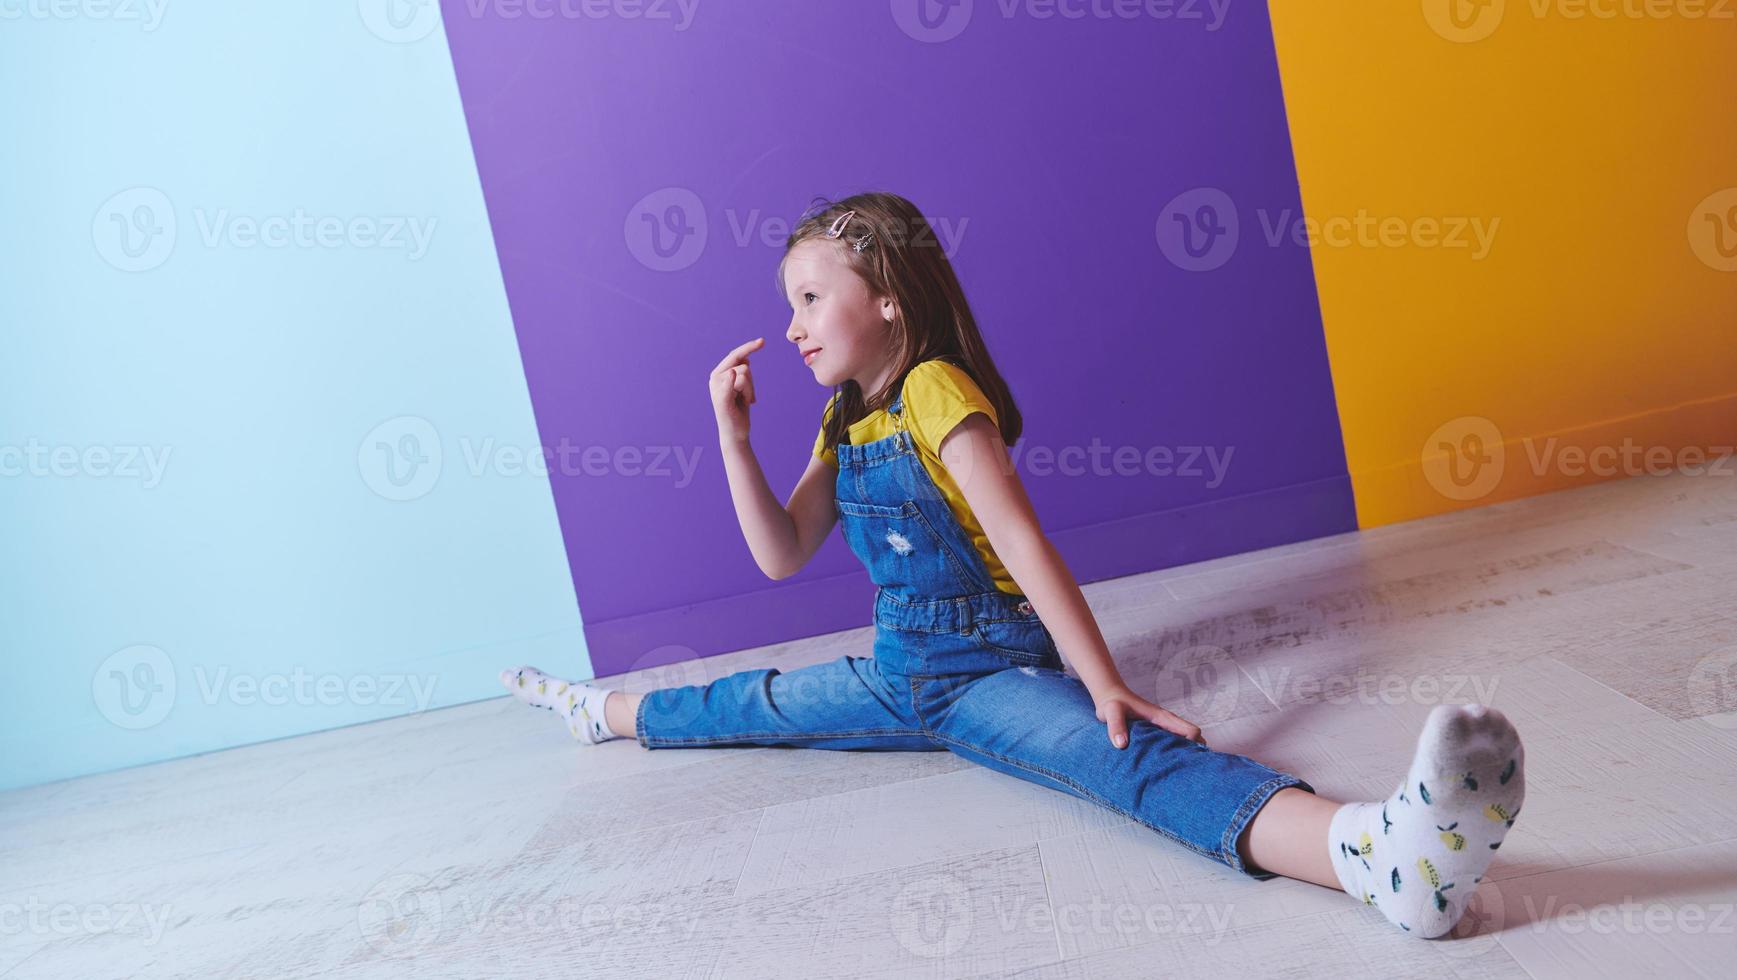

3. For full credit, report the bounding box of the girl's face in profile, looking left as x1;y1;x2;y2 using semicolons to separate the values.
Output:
783;238;895;393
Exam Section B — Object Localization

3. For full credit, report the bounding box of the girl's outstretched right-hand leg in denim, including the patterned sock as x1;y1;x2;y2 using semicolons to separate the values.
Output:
917;667;1525;937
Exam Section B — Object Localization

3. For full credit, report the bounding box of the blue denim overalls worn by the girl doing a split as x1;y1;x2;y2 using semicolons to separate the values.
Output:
636;382;1313;879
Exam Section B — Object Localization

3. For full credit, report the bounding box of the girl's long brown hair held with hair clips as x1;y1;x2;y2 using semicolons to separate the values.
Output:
778;191;1025;458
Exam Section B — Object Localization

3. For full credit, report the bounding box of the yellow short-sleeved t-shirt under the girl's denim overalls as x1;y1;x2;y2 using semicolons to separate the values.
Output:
815;358;1021;596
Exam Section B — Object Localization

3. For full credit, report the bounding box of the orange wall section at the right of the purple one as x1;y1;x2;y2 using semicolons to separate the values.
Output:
1270;0;1737;526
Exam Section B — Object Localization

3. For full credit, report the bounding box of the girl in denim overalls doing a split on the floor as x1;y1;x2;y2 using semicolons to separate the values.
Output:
500;193;1525;937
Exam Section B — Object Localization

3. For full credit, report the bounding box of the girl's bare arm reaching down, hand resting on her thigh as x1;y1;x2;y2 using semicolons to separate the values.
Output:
940;412;1200;749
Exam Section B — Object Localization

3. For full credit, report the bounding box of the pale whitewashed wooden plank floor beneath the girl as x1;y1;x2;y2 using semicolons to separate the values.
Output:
0;474;1737;980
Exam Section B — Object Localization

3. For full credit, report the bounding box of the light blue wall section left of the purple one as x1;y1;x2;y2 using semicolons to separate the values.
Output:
0;0;591;789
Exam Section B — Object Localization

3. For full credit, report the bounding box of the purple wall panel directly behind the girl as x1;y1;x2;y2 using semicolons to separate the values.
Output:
443;0;1355;676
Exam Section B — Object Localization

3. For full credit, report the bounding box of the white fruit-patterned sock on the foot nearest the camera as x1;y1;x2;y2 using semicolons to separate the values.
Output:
1327;704;1525;938
